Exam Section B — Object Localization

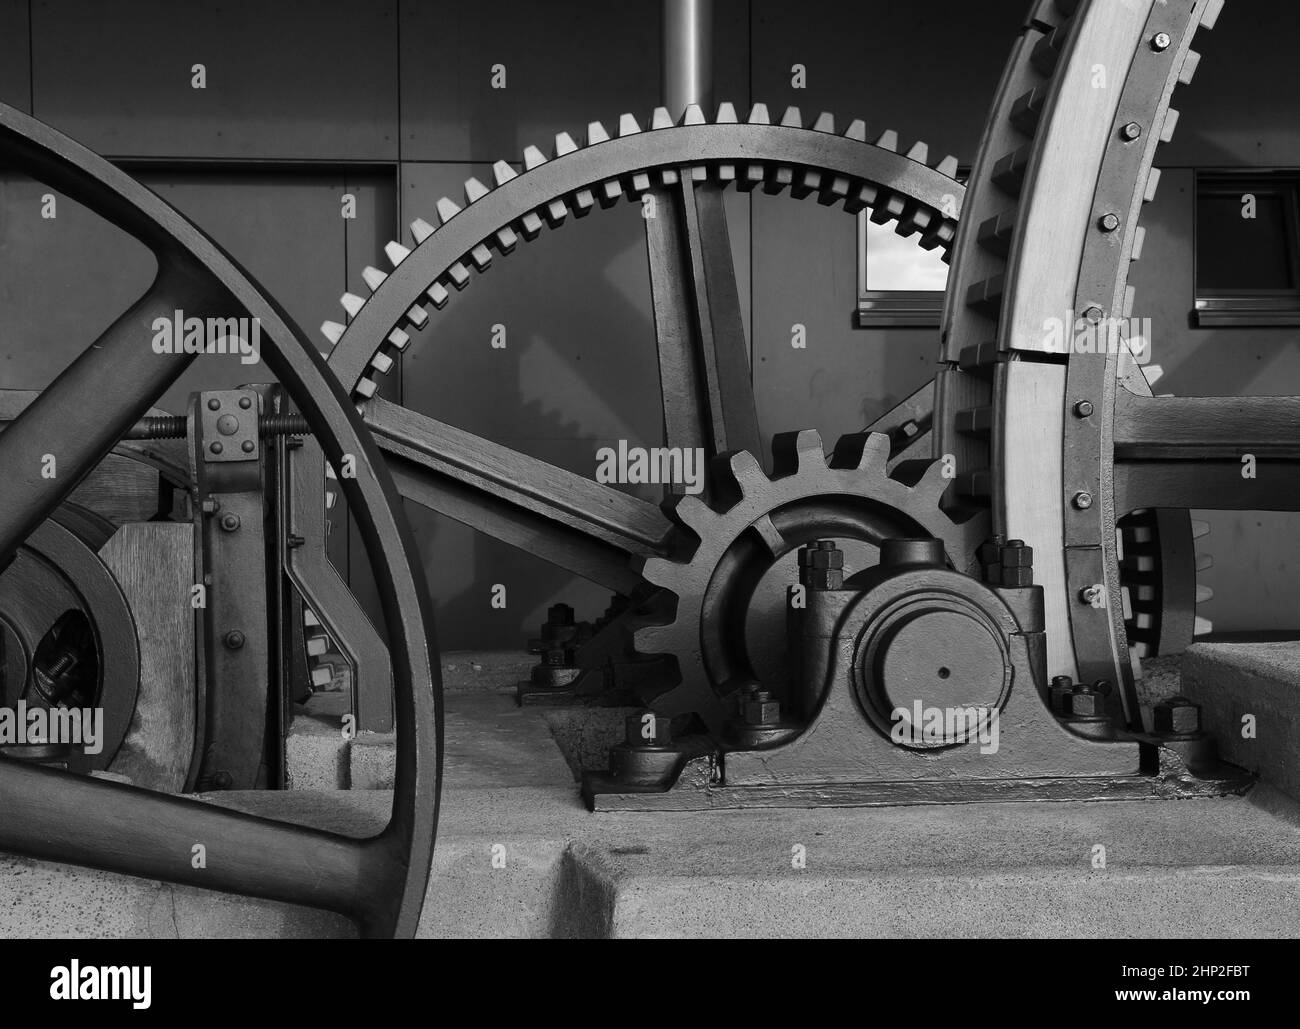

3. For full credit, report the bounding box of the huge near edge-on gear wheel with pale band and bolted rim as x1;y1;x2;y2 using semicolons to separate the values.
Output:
935;0;1216;729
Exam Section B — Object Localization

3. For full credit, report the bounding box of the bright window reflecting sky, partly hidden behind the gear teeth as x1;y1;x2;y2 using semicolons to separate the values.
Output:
854;168;970;329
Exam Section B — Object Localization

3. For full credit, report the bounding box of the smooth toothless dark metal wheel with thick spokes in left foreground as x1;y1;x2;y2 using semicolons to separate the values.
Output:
0;100;442;935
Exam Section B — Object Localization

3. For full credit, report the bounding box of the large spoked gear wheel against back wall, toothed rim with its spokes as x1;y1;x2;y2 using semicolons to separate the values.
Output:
309;103;965;722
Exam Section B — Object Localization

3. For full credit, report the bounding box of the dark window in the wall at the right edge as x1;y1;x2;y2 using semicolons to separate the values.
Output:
1195;170;1300;327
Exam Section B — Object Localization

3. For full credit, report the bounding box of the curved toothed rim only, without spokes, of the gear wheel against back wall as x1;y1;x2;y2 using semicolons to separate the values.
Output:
321;103;965;400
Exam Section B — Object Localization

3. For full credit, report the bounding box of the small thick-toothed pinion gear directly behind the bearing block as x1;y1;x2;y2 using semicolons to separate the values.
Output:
636;430;988;731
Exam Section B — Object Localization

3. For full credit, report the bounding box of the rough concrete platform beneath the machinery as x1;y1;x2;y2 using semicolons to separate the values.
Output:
0;652;1300;938
